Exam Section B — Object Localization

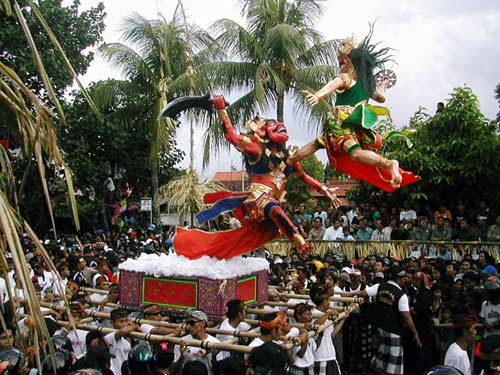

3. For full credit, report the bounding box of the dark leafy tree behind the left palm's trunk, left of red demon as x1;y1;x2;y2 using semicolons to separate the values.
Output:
57;80;184;226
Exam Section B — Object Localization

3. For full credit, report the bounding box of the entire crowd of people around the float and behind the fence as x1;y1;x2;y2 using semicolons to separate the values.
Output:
0;202;500;375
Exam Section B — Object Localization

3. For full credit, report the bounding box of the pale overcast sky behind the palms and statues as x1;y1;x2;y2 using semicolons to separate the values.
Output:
75;0;500;177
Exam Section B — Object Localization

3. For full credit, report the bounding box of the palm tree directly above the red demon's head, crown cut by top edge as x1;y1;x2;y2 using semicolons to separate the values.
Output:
205;0;338;151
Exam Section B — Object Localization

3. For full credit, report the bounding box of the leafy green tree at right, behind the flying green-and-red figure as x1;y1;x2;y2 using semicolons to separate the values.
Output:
348;87;500;212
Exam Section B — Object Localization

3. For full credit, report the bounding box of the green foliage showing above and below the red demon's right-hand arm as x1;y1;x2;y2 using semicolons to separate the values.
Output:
286;155;325;206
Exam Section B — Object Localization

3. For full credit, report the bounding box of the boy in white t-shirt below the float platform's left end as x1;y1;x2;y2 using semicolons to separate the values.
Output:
104;308;138;375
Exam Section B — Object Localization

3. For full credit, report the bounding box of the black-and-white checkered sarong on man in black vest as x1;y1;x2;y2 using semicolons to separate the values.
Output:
371;328;403;375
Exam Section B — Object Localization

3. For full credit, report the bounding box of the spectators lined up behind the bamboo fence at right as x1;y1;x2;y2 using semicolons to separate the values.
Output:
289;201;500;242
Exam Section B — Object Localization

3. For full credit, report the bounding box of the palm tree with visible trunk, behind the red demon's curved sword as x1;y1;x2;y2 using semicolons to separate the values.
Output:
100;10;218;220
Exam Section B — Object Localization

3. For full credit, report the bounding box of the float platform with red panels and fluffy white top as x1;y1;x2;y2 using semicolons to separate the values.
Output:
118;254;269;317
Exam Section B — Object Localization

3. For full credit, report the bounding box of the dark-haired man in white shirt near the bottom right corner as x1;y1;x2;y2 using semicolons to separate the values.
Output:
444;314;477;375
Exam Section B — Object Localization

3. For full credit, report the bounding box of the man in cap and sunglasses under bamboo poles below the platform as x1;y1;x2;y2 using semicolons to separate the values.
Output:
174;310;223;375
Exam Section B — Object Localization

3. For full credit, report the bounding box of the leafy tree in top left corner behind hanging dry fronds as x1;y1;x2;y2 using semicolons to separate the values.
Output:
0;0;105;96
